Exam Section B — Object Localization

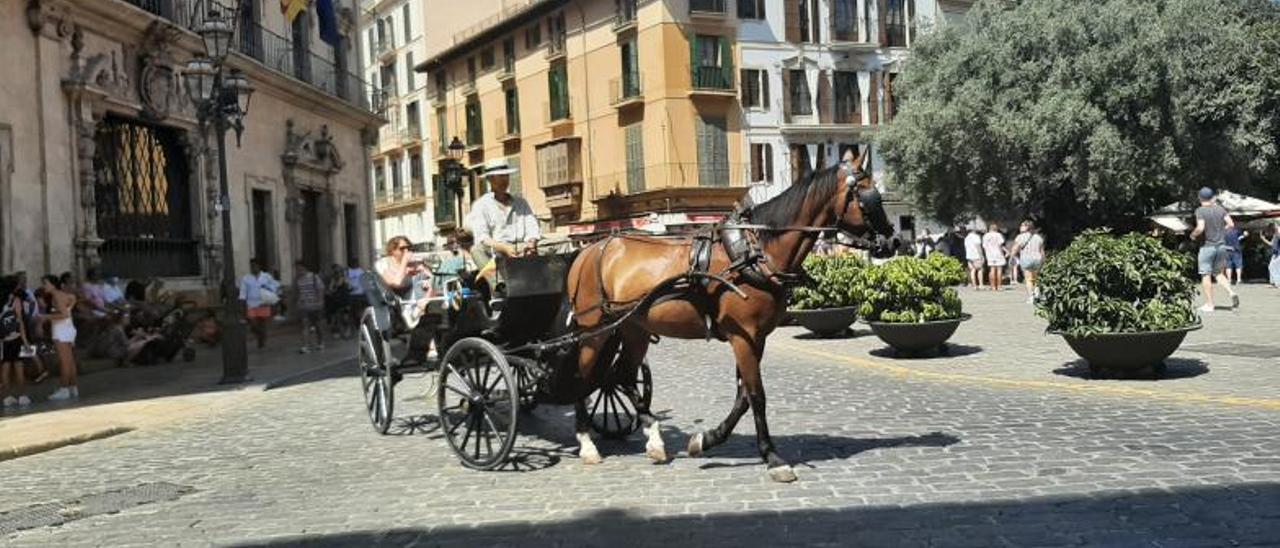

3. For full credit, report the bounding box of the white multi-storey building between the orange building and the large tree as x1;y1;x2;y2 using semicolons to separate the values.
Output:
737;0;972;238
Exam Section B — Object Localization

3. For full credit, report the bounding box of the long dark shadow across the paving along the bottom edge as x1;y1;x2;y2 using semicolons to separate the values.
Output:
230;480;1280;547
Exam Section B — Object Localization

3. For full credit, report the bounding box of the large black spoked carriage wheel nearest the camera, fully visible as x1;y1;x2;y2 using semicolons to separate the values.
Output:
435;337;520;470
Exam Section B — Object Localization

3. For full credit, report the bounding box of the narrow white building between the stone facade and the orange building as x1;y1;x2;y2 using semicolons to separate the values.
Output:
360;0;438;247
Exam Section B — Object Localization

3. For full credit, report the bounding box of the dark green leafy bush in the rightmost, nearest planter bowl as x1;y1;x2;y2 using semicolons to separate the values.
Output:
1036;230;1199;337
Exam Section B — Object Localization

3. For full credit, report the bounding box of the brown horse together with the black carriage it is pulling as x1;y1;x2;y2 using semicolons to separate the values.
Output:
350;152;893;481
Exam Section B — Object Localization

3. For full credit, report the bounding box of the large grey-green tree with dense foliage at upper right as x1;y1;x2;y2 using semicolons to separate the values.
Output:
879;0;1280;241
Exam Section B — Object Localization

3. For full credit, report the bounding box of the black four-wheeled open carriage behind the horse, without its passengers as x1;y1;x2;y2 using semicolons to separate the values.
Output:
358;254;653;470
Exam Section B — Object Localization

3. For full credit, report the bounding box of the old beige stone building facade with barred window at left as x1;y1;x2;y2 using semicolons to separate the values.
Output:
0;0;383;296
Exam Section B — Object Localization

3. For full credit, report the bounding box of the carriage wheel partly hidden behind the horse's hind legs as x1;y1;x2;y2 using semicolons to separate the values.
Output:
586;360;653;438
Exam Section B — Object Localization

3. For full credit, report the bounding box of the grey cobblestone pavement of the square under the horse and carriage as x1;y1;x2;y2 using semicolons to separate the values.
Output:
0;284;1280;547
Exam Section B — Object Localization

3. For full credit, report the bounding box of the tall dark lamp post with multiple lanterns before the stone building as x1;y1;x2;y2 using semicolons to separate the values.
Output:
183;10;253;384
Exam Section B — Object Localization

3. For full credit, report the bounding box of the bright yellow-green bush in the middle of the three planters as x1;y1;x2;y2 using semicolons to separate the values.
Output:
850;254;965;324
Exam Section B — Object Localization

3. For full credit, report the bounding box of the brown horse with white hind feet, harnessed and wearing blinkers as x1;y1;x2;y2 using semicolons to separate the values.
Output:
568;152;892;481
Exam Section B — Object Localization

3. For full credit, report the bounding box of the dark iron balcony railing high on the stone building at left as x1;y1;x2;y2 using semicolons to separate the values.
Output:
125;0;370;110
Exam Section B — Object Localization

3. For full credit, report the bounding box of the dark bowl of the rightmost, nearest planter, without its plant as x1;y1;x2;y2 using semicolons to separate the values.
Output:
1056;324;1202;378
